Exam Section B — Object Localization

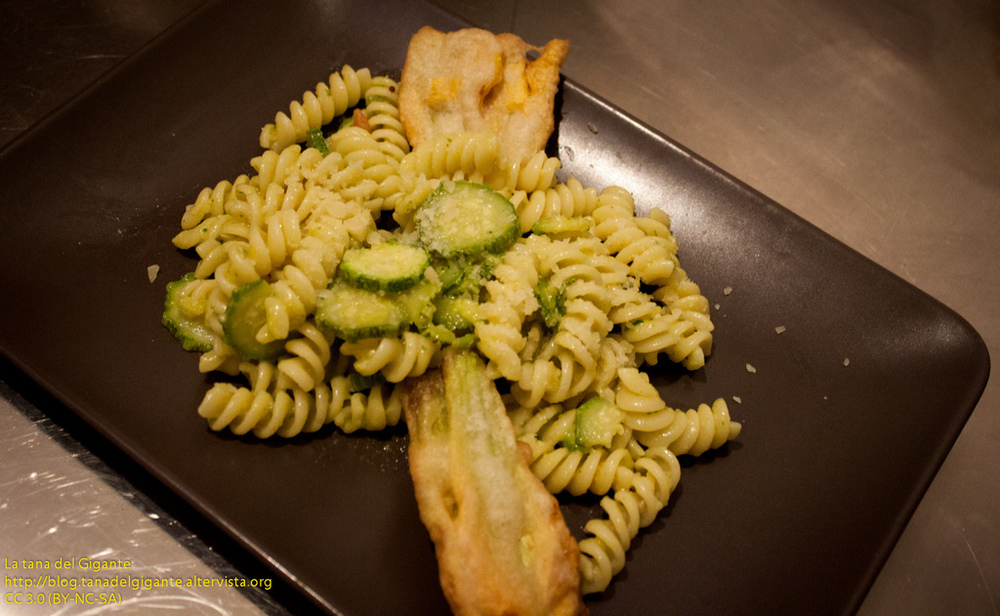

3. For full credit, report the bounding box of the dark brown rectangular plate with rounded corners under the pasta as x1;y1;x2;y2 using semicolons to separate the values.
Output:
0;0;989;616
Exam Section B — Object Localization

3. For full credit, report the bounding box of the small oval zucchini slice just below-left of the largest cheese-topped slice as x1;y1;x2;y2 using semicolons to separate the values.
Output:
340;244;430;293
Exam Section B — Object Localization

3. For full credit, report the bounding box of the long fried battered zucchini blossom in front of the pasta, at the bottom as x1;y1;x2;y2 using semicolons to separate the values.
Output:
404;352;587;616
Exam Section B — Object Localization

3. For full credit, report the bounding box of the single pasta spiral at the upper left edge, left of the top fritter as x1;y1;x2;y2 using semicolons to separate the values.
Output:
260;66;372;150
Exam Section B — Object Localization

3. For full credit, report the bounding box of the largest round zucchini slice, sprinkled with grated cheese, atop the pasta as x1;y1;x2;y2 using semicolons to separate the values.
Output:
416;180;521;257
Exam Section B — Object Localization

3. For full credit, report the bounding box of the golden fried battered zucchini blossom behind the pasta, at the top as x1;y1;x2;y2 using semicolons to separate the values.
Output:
399;26;569;160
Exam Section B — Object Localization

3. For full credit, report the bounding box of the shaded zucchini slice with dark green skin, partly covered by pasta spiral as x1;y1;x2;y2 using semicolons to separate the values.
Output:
222;280;285;361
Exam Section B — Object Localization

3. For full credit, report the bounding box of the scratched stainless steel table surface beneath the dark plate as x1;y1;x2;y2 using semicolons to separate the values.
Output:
0;0;1000;615
